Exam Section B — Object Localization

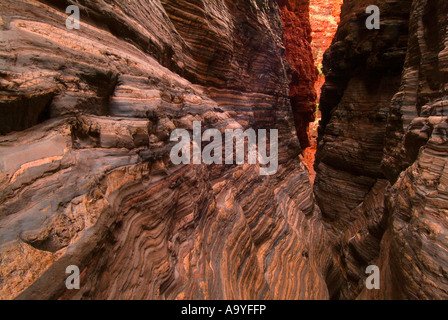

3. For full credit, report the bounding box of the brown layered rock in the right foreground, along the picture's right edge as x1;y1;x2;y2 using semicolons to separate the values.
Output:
362;0;448;299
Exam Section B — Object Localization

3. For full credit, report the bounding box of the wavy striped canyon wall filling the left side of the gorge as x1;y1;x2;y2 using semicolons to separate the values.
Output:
0;0;330;299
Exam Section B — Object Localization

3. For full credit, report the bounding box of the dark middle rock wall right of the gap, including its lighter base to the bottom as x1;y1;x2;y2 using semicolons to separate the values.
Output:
314;0;411;298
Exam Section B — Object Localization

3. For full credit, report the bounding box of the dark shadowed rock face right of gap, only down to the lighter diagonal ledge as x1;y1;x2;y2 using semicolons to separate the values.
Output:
315;0;410;227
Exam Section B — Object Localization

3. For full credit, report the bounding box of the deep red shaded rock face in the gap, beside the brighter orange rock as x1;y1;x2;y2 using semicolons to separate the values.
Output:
277;0;317;150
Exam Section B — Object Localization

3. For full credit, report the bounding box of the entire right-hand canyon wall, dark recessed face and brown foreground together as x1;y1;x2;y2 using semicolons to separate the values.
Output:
314;0;448;299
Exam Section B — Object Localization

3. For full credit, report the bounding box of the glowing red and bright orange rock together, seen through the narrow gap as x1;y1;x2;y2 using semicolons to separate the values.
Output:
277;0;343;183
